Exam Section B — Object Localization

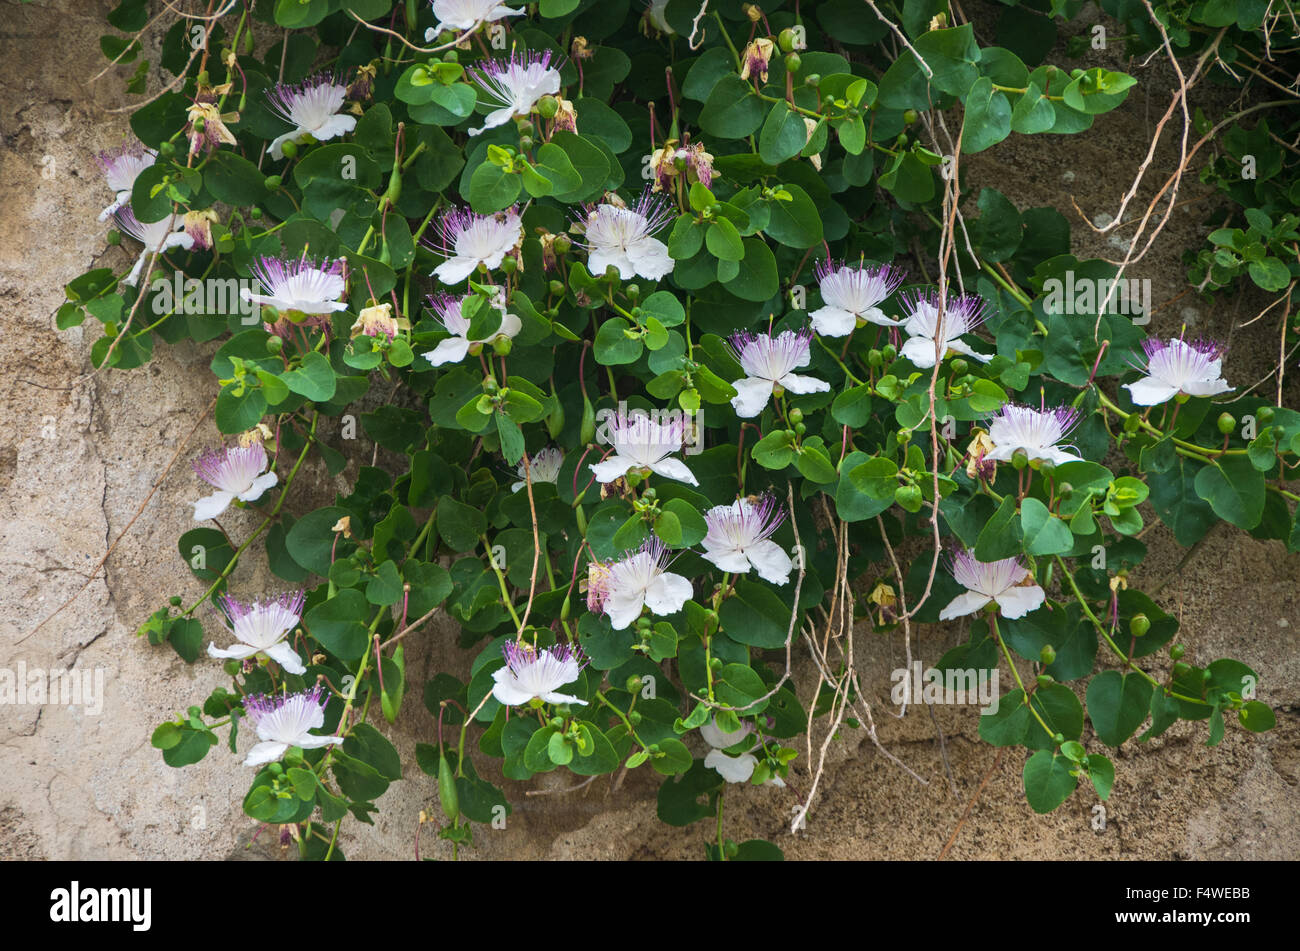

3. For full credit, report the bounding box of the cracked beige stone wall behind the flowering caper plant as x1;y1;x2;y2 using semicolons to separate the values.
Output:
0;0;1300;859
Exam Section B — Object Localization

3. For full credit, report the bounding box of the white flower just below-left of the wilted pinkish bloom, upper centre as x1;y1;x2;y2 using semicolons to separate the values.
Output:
577;187;673;281
